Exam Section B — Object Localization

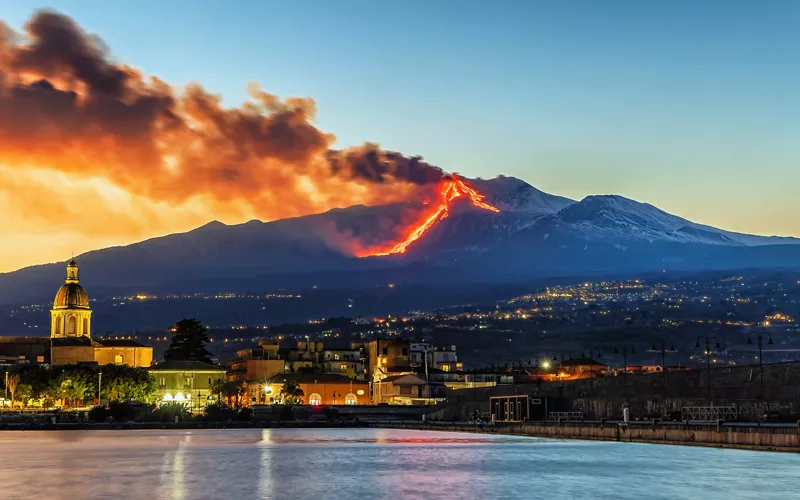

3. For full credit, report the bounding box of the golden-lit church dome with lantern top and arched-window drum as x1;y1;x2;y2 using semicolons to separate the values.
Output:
50;259;92;339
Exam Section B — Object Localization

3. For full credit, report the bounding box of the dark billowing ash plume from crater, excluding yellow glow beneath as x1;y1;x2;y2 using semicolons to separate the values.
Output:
0;11;446;213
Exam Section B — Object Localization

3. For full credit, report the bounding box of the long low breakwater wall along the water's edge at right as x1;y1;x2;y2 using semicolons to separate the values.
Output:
372;422;800;452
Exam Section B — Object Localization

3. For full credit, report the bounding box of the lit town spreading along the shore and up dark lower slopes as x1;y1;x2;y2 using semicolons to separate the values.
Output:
0;260;800;430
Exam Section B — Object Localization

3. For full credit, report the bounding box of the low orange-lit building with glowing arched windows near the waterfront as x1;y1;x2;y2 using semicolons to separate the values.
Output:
264;373;370;406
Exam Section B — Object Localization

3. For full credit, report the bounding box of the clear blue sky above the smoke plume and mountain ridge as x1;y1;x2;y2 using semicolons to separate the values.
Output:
6;0;800;236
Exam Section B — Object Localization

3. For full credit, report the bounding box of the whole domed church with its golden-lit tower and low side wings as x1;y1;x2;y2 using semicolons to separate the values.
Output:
0;259;153;367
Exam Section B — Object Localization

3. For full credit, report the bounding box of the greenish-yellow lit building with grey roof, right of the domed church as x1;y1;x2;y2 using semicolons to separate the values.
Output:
147;361;225;408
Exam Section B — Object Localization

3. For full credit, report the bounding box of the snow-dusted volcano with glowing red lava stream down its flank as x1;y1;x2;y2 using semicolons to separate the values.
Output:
0;177;800;304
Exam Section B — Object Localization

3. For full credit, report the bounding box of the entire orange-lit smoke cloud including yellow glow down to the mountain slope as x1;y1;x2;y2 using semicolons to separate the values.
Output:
0;11;444;271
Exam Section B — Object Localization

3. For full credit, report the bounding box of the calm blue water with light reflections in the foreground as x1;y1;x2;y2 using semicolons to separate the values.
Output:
0;429;800;500
